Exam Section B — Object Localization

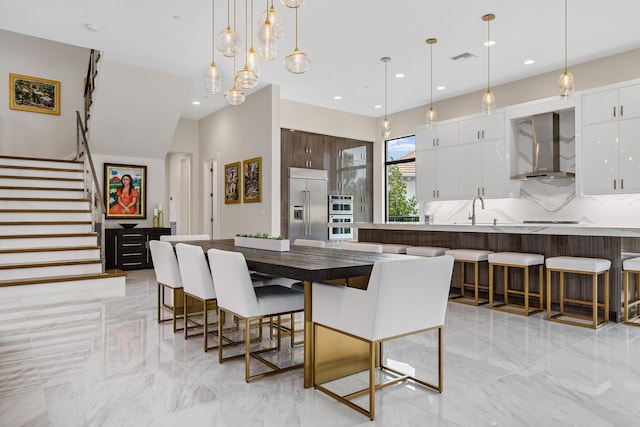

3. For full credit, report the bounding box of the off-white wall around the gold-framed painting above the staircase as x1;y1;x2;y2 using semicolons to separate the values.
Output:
0;30;90;158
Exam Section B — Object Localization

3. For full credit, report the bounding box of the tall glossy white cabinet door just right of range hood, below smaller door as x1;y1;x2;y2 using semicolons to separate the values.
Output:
582;122;619;194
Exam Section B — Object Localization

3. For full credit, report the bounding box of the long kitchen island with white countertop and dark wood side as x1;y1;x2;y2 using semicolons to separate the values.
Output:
352;223;640;322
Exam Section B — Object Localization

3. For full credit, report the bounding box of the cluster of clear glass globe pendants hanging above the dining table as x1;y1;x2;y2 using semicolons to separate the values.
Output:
205;0;311;105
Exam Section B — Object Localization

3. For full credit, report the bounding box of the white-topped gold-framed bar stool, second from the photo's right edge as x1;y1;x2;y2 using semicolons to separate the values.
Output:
546;256;611;329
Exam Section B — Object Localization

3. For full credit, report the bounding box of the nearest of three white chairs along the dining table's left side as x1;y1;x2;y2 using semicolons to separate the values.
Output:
207;249;304;382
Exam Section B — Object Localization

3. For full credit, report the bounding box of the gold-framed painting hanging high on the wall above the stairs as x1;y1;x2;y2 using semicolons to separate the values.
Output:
9;73;60;115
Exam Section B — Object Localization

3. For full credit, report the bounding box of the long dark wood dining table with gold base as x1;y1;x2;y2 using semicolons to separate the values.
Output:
175;239;406;388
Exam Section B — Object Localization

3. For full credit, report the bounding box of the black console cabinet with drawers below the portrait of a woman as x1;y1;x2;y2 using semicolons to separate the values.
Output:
105;228;171;270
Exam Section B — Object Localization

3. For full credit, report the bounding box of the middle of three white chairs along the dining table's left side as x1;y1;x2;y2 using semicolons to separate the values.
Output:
176;243;220;352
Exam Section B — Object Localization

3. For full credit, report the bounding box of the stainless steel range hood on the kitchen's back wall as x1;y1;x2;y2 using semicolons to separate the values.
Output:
511;113;575;180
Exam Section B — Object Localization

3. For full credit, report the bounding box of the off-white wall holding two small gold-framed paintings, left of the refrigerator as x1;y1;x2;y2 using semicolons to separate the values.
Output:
200;86;280;238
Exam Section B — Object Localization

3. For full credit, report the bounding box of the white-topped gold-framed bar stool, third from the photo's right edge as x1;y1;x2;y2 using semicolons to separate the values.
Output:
489;252;544;316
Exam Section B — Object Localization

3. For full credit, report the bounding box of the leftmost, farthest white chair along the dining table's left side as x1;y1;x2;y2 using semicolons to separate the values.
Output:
149;240;182;333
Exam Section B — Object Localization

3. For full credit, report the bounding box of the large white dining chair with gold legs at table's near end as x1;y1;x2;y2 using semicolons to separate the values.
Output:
313;255;453;420
